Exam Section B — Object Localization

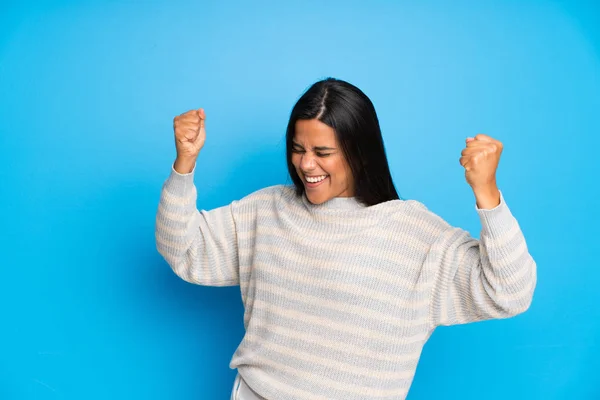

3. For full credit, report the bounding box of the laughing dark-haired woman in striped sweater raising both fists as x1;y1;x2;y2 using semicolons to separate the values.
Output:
156;78;536;400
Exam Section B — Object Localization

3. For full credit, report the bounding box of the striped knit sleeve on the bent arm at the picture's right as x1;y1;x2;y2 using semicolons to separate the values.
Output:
426;193;537;327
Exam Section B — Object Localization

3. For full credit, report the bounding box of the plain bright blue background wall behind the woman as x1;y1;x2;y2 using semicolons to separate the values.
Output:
0;0;600;400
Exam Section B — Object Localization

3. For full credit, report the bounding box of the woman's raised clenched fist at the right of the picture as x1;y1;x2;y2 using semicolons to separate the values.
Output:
460;134;503;190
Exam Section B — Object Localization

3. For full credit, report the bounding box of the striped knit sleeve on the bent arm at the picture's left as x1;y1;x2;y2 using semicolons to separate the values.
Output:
155;167;239;286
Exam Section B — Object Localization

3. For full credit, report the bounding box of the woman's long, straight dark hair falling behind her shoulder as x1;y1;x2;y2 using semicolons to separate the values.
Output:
286;78;399;206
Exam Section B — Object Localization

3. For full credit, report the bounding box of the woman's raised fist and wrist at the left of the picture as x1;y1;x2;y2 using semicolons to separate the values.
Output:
173;108;206;173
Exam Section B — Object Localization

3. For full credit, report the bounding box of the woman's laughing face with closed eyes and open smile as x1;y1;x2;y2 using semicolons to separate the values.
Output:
292;119;354;204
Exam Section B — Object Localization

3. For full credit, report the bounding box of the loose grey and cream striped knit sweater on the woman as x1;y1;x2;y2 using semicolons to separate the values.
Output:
156;164;536;400
